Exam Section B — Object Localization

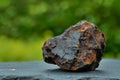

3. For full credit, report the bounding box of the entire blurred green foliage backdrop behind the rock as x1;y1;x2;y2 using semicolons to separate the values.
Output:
0;0;120;61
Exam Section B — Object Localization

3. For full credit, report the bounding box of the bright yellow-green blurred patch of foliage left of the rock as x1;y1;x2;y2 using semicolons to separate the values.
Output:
0;31;52;62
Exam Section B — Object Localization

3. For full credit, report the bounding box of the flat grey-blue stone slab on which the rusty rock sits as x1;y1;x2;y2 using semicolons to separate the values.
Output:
0;59;120;80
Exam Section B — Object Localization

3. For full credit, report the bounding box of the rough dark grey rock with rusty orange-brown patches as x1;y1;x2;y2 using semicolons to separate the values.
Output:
42;21;106;71
